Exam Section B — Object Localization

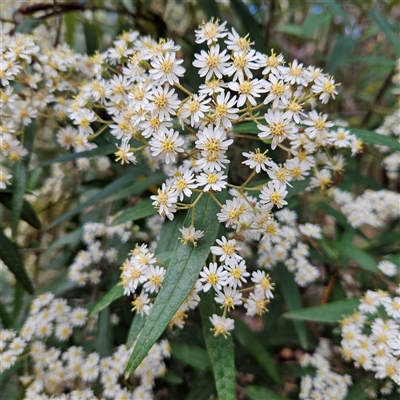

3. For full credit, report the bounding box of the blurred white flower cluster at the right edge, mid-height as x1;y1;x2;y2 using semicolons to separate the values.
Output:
329;188;400;228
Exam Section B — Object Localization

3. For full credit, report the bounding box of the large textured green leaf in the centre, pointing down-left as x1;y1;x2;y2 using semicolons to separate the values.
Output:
126;190;226;373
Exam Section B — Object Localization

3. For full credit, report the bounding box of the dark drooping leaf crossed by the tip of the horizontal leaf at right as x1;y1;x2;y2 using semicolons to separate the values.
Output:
276;264;309;349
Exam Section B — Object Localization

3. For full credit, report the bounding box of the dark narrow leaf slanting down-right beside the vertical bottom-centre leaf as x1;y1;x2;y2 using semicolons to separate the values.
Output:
234;318;282;385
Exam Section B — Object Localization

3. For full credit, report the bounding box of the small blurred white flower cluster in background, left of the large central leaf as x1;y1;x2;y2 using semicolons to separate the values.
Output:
68;217;132;286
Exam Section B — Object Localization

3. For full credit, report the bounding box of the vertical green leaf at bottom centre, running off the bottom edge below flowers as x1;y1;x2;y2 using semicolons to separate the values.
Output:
199;292;235;400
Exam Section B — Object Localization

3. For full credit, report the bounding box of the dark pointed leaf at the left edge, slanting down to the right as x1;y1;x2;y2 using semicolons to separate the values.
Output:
0;230;33;294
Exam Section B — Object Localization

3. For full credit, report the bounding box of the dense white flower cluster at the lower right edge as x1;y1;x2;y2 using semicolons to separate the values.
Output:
341;290;400;385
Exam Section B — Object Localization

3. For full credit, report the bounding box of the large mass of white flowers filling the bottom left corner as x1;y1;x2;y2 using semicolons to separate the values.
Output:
0;293;170;400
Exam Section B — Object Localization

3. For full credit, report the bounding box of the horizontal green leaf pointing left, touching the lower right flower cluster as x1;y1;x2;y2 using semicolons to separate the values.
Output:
283;299;360;323
